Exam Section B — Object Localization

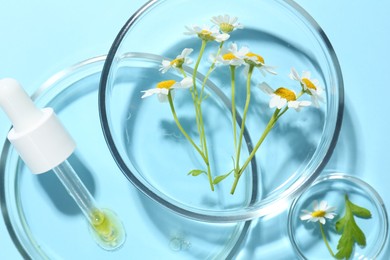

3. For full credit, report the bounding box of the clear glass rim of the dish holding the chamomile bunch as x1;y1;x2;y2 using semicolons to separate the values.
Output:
99;0;344;222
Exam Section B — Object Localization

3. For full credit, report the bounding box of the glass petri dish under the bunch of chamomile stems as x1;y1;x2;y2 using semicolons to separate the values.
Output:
99;0;344;222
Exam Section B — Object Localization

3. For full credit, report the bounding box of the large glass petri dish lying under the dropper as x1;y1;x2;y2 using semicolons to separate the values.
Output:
0;56;250;259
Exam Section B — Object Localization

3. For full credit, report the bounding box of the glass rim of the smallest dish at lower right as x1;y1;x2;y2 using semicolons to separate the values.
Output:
287;171;389;259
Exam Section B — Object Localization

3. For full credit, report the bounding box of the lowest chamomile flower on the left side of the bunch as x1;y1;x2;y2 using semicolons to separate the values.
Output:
141;77;192;102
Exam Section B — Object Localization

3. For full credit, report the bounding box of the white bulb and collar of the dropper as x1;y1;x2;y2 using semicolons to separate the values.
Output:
0;78;76;173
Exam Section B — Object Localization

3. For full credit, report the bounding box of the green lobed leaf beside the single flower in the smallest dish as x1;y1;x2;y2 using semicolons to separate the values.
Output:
335;195;371;259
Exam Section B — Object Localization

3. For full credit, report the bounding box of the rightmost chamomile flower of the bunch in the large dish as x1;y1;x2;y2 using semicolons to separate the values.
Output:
290;68;324;107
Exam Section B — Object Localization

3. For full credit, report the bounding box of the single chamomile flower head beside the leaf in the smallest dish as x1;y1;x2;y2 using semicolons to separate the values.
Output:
300;200;336;225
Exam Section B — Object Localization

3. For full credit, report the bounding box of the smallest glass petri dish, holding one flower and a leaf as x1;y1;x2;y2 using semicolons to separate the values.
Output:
288;173;388;259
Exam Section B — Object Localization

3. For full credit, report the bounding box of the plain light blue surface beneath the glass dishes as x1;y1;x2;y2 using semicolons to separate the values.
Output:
0;0;390;259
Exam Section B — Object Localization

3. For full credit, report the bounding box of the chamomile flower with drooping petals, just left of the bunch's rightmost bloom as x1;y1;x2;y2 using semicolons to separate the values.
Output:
259;82;311;111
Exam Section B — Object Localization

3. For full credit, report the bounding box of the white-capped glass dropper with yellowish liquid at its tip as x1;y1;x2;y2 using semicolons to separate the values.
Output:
0;78;126;250
